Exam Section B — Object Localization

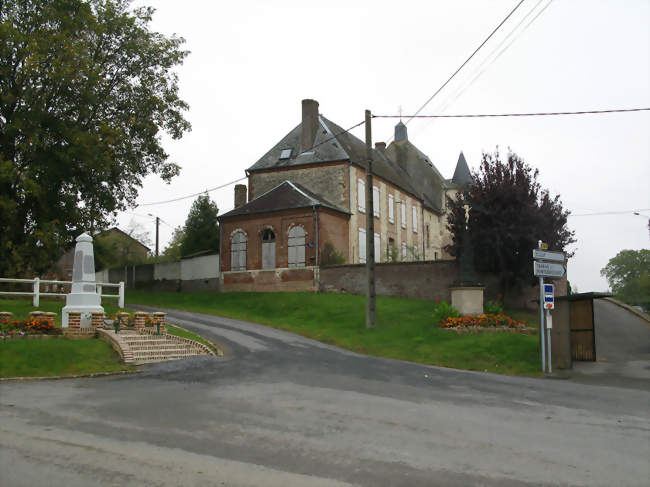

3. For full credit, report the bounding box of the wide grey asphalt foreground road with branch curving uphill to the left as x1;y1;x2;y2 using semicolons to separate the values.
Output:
0;306;650;487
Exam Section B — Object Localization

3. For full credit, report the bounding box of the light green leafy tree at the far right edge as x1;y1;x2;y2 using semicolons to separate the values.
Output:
600;249;650;307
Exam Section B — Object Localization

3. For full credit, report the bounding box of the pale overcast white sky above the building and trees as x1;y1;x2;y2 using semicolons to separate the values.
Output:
118;0;650;292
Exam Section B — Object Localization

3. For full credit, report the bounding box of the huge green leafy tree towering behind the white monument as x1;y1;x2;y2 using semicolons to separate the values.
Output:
0;0;190;275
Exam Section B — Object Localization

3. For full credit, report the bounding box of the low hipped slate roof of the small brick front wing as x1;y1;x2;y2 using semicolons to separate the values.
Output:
218;181;350;220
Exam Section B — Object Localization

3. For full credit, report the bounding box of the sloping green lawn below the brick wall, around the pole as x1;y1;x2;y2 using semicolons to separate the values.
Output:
126;291;540;375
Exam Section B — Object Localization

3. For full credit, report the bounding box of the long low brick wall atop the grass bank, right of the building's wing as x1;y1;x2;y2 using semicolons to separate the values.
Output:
319;260;567;309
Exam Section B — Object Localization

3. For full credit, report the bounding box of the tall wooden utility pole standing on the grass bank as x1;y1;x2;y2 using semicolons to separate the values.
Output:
366;110;376;328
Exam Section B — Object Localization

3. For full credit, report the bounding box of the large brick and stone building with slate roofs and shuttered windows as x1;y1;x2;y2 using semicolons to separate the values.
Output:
219;100;471;290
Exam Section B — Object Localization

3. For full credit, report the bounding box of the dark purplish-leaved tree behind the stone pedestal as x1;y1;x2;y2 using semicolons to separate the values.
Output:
445;151;576;290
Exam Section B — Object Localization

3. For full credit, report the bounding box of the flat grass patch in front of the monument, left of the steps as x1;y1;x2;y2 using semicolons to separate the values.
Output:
0;339;135;377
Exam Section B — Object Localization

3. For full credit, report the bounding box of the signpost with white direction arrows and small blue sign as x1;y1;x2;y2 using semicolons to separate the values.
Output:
533;240;566;374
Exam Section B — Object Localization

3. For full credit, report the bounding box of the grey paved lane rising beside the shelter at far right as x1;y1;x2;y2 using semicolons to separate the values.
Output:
572;299;650;388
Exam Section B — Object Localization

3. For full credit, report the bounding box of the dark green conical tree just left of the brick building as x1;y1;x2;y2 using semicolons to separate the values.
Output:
181;194;219;257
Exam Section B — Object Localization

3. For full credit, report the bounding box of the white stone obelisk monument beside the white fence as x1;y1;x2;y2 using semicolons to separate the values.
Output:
61;233;104;328
